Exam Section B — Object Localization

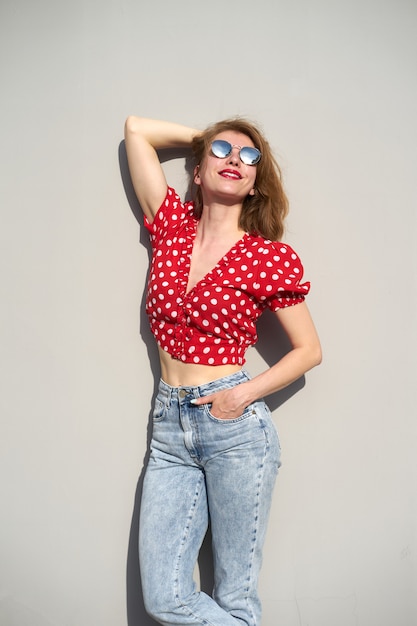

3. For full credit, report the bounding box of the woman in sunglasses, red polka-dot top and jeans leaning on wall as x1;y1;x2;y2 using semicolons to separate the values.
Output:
125;116;321;626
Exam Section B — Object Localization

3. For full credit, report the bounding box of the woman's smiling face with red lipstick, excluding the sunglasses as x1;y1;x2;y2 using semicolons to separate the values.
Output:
194;130;256;203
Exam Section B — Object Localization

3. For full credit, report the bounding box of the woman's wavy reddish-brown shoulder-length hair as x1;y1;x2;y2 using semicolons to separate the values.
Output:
192;117;288;241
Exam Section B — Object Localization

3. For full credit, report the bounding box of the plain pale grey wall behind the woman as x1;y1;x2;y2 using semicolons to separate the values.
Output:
0;0;417;626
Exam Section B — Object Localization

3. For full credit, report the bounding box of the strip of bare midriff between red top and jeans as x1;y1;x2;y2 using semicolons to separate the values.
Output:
159;348;242;387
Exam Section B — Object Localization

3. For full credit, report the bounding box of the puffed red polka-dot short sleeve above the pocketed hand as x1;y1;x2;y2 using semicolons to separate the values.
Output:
254;242;310;311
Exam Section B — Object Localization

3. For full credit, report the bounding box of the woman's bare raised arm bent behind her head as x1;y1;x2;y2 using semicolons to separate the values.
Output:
125;115;200;222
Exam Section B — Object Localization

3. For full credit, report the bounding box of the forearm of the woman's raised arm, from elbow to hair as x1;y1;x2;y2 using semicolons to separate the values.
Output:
125;115;201;150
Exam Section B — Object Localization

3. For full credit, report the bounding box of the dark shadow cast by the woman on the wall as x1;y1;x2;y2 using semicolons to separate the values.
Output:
119;142;305;626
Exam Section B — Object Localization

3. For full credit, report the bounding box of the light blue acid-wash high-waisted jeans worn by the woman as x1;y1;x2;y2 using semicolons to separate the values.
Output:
139;370;280;626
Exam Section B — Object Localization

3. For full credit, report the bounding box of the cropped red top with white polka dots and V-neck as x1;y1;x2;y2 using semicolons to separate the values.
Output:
145;187;310;365
